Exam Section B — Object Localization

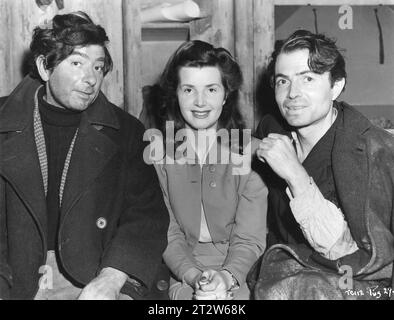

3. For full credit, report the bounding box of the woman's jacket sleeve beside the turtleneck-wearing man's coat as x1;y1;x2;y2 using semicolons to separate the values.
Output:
155;164;199;281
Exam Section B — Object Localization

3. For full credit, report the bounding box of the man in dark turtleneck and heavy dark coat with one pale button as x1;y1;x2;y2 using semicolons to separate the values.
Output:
0;12;168;299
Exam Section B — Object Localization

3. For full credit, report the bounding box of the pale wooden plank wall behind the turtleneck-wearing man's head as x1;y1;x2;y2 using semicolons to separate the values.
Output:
0;0;123;106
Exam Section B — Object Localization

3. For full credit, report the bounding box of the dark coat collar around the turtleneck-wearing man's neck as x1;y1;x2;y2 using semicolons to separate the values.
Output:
0;76;119;133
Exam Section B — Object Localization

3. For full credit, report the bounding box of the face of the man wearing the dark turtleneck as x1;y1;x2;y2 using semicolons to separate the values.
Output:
44;45;105;111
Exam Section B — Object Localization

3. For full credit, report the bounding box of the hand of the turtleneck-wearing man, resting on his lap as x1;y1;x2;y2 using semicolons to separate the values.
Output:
78;268;127;300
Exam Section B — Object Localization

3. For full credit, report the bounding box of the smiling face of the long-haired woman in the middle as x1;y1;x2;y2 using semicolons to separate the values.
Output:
177;67;226;130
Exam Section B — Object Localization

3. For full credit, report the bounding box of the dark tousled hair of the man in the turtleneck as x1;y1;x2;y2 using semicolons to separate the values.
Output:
30;11;113;79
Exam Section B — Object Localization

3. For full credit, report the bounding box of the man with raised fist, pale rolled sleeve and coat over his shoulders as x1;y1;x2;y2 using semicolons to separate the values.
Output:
249;30;394;299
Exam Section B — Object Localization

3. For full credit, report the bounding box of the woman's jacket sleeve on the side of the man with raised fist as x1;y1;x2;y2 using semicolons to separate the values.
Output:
223;171;268;285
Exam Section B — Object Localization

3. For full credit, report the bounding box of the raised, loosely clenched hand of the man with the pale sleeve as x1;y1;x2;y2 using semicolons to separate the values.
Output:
256;133;310;197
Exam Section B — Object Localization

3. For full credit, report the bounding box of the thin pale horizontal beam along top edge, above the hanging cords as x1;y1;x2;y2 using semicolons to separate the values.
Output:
275;0;394;6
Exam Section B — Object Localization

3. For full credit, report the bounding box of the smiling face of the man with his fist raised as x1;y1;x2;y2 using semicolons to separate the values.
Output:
275;49;342;128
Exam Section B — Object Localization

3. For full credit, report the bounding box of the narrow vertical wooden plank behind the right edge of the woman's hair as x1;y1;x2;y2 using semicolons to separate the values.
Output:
234;1;254;129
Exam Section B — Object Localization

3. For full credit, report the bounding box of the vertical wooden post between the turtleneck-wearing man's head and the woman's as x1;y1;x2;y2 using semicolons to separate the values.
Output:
122;0;143;117
